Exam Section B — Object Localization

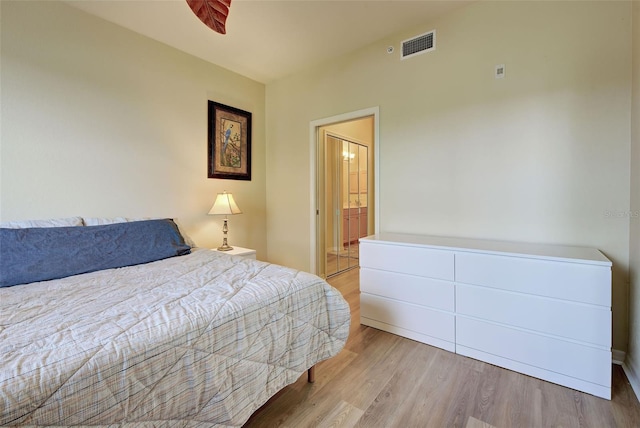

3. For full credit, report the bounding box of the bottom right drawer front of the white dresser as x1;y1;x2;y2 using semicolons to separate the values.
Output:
456;315;611;387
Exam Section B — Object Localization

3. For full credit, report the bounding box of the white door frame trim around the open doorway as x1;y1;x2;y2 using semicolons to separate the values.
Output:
309;106;380;274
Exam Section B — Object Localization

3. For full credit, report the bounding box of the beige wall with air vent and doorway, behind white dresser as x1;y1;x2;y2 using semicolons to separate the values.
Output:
267;1;631;350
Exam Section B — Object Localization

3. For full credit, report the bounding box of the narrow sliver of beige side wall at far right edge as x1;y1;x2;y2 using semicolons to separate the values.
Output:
625;1;640;388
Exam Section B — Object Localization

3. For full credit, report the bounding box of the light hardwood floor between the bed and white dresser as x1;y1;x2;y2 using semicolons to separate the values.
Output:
245;269;640;428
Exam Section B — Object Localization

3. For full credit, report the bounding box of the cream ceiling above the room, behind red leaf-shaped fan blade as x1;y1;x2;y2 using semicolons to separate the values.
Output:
67;0;470;83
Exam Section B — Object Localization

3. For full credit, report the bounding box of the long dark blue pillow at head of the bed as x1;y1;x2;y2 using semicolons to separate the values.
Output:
0;219;191;287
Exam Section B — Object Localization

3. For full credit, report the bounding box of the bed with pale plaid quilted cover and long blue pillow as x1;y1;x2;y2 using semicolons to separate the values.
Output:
0;220;350;427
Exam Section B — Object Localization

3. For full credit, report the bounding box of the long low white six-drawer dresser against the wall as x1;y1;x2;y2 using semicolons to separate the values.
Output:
360;234;611;399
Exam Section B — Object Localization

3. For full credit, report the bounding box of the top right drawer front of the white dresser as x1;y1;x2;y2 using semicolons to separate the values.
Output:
455;252;611;307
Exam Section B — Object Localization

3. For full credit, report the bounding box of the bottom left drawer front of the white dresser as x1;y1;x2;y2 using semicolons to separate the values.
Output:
360;293;455;342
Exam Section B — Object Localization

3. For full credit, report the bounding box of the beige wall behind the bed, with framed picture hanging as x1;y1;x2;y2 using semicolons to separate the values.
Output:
0;1;266;258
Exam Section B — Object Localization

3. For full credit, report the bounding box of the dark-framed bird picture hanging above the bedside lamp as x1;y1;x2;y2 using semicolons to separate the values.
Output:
208;101;251;180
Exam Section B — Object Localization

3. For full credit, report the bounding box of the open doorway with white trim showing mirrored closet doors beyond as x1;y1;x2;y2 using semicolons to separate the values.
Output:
311;108;378;278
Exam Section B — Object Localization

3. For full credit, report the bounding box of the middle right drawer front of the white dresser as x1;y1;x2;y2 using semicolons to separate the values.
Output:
456;284;611;349
